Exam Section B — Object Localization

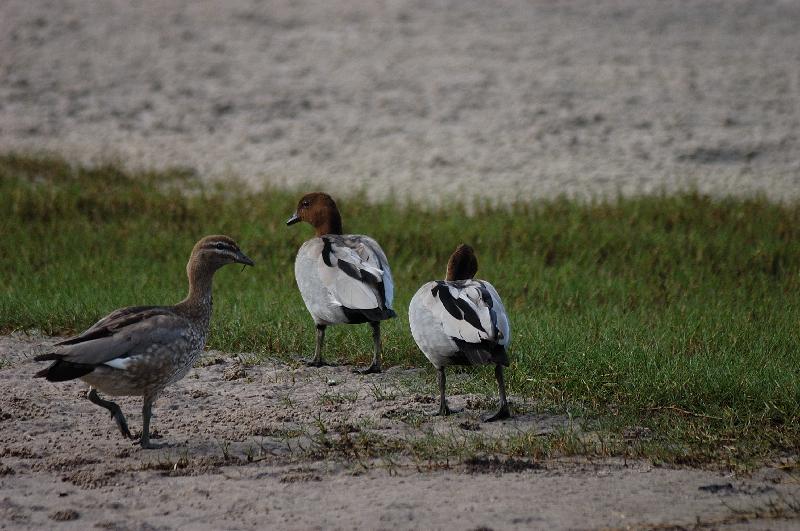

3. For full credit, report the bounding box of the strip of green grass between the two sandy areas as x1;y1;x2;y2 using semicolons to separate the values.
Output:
0;155;800;462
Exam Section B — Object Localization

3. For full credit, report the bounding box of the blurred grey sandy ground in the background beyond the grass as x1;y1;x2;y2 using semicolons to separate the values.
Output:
0;0;800;203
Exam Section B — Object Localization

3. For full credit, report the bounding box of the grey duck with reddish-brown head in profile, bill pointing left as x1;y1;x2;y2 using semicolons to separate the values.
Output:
286;192;397;374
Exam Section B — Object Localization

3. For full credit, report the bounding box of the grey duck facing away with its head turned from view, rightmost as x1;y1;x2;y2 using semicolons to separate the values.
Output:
408;244;511;422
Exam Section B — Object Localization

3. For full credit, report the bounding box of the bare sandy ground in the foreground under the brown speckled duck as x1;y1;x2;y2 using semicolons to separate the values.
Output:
0;335;800;529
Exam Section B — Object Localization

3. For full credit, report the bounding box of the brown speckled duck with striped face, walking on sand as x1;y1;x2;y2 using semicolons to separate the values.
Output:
34;236;253;448
